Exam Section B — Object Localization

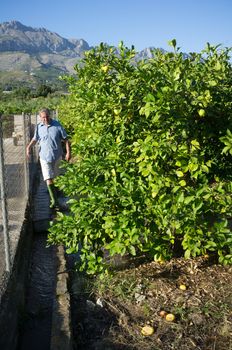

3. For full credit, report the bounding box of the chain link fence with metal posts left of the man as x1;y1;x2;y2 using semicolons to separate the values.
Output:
0;114;38;288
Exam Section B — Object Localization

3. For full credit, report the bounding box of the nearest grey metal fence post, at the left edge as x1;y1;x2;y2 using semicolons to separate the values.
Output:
0;115;10;272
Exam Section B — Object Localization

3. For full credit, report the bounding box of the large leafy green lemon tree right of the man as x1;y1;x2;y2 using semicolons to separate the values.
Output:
49;40;232;274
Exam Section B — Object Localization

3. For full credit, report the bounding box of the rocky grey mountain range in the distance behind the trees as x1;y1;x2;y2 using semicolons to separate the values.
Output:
0;21;158;88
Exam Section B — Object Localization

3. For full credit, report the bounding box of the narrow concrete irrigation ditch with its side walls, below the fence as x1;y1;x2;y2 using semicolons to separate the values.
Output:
0;169;72;350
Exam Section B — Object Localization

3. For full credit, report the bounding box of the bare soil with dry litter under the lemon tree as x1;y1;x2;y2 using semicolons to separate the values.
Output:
71;257;232;350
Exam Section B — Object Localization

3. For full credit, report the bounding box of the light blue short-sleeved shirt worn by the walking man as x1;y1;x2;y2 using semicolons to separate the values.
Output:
33;119;67;162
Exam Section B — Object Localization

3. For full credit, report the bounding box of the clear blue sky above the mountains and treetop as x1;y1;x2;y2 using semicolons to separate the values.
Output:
0;0;232;52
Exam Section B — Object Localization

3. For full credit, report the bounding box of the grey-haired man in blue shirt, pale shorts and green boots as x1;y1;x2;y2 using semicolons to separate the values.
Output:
26;108;71;208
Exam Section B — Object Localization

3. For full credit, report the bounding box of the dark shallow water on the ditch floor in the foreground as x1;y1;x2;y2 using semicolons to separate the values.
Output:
17;232;56;350
